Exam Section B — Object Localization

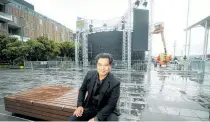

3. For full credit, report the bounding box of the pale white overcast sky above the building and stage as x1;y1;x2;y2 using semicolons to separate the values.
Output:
26;0;210;55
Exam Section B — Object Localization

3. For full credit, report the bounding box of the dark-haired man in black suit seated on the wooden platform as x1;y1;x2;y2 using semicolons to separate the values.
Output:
69;53;120;121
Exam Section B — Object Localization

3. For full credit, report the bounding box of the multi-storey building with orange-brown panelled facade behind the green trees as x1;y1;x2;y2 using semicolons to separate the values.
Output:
0;0;73;41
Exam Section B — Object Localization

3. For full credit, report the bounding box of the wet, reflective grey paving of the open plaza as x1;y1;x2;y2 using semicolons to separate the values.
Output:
0;63;210;121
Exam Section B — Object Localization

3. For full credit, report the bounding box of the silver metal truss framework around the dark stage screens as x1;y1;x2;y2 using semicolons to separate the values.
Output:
75;0;153;71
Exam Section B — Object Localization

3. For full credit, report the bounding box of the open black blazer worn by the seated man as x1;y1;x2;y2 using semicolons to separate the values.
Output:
77;71;120;121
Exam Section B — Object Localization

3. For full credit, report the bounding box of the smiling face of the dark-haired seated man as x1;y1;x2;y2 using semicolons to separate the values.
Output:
97;58;111;76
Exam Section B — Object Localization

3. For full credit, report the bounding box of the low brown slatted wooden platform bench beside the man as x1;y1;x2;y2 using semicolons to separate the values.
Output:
4;86;78;121
